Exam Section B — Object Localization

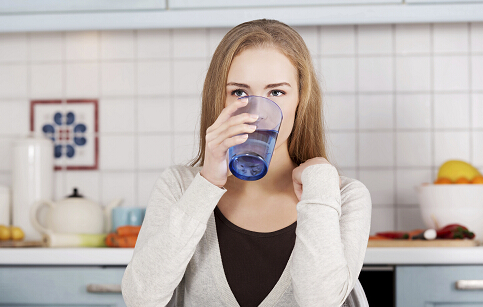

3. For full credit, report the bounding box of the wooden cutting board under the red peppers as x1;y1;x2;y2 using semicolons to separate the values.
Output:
367;239;479;247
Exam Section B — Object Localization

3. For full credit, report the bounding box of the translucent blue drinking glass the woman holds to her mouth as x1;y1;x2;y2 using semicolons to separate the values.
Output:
228;96;283;181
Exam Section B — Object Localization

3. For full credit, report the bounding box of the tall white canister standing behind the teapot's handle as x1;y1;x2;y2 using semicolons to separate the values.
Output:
12;136;54;241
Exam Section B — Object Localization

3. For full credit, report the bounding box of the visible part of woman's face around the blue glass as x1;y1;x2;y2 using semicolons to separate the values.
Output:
225;48;299;153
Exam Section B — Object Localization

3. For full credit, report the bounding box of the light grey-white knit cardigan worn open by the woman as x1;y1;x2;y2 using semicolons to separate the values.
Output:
122;164;371;307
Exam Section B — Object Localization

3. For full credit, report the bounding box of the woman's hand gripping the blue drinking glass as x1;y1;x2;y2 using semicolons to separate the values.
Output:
200;99;258;188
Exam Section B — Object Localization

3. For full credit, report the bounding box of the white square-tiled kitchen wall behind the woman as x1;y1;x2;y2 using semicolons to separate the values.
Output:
0;23;483;233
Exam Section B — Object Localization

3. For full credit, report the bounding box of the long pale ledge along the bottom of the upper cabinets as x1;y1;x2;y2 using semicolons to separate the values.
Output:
0;1;483;32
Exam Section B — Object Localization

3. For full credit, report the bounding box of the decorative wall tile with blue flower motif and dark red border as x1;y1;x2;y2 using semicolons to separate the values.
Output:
30;99;99;170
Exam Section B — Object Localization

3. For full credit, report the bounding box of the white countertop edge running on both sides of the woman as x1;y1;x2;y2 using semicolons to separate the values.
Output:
0;247;483;266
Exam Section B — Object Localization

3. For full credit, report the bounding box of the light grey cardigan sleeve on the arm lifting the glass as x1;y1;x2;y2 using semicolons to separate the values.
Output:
122;168;226;307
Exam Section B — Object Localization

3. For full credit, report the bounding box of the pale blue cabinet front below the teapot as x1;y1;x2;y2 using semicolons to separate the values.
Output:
0;266;126;307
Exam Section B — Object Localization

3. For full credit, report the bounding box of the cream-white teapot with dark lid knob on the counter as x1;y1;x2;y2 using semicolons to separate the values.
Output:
30;188;122;234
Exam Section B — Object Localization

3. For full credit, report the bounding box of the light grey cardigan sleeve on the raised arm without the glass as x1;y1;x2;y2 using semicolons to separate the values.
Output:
291;164;371;307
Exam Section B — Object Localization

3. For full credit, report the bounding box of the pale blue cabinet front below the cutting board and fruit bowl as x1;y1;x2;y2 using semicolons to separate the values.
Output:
396;265;483;307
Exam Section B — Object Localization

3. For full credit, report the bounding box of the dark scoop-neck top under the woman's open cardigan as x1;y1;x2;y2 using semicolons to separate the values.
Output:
215;207;297;307
